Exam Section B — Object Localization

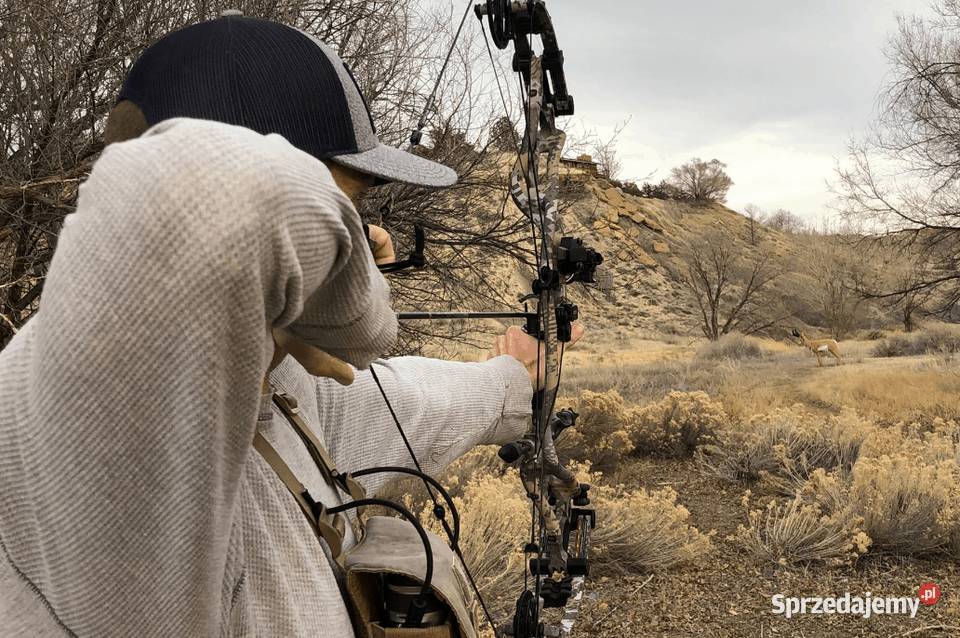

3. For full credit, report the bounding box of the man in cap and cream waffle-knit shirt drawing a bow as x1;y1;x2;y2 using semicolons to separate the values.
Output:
0;15;582;638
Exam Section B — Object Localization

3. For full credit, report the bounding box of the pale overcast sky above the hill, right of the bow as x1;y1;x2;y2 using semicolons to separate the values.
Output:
457;0;929;225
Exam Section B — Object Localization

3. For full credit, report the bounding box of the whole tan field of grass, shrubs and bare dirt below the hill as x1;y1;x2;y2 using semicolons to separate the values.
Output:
418;335;960;638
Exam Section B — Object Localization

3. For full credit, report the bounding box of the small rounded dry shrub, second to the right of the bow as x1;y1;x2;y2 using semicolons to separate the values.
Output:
630;391;727;458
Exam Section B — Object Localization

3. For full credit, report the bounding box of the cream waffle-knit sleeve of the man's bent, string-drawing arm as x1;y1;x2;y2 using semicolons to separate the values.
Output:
0;120;396;636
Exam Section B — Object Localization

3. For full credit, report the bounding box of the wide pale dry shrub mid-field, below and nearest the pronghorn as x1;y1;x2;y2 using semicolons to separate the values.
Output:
697;405;875;496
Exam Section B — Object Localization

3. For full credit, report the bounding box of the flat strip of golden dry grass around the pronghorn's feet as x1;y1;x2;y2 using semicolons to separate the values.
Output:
563;330;960;423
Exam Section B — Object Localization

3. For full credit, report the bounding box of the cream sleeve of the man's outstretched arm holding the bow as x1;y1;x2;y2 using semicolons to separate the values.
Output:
317;356;533;494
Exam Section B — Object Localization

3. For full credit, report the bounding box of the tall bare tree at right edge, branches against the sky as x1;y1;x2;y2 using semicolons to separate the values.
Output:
837;0;960;313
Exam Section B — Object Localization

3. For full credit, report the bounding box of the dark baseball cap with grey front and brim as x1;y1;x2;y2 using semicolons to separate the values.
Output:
118;11;457;187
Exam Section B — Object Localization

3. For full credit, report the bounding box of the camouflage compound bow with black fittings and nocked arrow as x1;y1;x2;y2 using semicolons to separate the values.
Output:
373;0;603;638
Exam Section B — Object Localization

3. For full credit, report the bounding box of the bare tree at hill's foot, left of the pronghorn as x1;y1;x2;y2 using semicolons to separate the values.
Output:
679;233;782;341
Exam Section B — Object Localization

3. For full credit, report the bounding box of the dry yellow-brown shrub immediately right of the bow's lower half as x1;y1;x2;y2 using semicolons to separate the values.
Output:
557;390;633;472
